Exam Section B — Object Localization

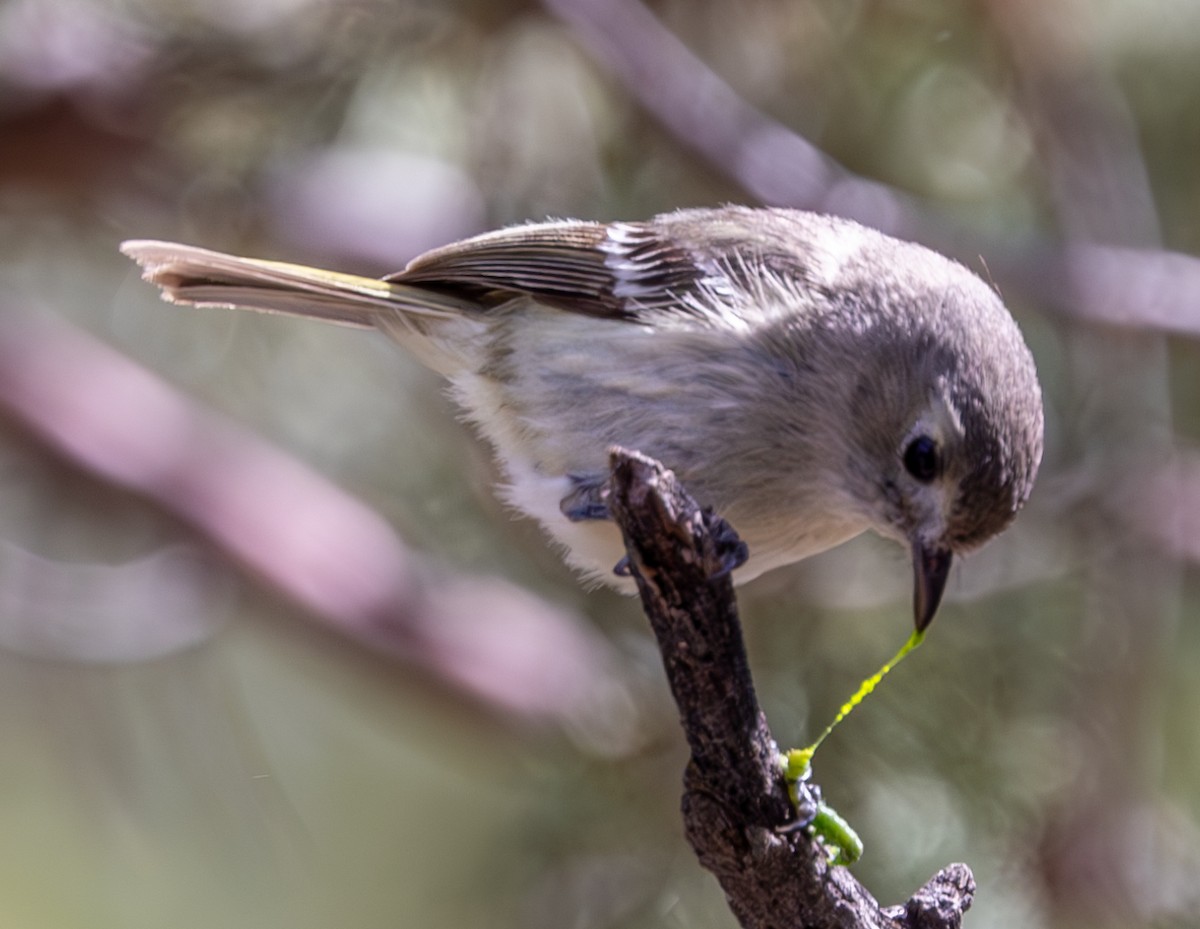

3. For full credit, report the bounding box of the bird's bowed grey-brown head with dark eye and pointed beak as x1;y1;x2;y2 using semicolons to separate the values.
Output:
835;252;1043;630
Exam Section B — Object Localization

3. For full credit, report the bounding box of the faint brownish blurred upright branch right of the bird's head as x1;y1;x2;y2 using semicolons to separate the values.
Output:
984;0;1180;924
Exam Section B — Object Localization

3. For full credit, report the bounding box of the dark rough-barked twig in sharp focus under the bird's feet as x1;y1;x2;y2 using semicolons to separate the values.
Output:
608;449;974;929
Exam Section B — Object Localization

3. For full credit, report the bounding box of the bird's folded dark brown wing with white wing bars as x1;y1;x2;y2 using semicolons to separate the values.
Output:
396;221;726;319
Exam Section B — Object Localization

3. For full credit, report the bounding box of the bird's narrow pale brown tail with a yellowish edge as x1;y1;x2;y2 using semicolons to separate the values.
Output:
121;240;473;329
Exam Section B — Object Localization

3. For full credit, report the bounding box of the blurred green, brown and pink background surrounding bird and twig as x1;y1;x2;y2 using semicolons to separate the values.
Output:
0;0;1200;929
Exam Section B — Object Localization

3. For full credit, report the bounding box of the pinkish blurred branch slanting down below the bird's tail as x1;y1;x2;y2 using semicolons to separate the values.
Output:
0;306;638;735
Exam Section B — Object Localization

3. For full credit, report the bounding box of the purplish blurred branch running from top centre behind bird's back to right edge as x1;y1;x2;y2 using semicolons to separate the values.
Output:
542;0;1200;337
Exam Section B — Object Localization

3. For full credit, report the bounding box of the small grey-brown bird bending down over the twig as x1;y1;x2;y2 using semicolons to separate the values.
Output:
121;205;1044;630
